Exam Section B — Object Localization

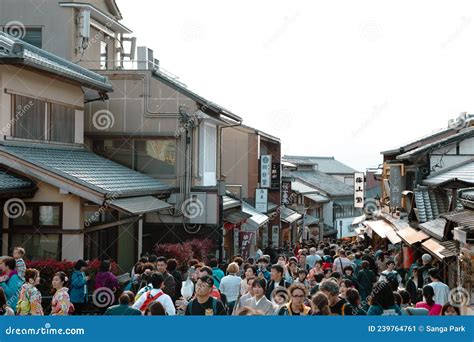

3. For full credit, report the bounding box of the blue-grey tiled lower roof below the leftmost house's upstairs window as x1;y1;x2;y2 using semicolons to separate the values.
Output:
0;144;169;197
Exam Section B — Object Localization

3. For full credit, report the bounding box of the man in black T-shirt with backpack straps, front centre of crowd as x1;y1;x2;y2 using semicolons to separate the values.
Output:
185;275;226;316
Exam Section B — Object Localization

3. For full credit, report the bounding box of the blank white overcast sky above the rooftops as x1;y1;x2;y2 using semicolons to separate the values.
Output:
117;0;474;170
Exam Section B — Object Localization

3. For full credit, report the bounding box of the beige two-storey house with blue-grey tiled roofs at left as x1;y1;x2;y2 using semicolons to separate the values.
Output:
0;33;171;268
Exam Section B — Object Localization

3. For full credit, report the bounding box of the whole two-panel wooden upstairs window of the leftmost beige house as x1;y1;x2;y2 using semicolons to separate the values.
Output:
11;94;75;143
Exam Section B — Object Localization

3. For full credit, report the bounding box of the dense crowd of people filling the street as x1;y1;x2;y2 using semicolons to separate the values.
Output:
0;240;460;316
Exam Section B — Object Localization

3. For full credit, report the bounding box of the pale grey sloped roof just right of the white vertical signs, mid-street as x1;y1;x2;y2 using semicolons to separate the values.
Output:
283;170;354;197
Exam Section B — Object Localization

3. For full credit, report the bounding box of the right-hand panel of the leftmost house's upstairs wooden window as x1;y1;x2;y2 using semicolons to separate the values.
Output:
49;103;75;143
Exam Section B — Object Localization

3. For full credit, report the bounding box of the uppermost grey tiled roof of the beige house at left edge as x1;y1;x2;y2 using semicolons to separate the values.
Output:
0;32;112;91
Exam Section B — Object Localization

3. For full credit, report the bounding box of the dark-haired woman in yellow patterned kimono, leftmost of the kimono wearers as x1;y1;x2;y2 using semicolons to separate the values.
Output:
16;268;44;316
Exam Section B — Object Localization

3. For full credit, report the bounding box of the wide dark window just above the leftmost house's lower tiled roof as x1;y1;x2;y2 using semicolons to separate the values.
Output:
93;138;176;177
